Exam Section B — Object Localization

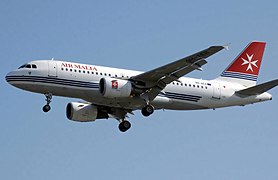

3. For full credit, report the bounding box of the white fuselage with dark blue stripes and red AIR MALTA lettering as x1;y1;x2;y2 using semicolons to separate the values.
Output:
6;60;271;110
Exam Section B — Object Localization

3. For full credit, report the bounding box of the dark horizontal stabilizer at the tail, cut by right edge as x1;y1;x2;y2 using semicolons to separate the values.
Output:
236;79;278;96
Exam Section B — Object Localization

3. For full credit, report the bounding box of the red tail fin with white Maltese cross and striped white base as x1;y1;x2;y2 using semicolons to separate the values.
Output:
218;41;266;87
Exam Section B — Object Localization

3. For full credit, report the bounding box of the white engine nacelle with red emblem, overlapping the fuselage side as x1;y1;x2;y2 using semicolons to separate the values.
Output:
99;78;132;98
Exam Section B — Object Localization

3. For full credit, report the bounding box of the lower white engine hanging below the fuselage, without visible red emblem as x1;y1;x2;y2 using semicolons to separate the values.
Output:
66;102;108;122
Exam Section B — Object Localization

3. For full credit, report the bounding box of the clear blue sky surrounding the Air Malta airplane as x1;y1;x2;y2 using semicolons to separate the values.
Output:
0;0;278;180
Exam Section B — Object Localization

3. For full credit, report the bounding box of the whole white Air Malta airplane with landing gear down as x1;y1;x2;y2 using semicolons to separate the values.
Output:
6;41;278;132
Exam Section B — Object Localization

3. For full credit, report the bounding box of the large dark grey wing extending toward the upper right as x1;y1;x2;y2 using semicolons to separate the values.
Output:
130;46;226;100
